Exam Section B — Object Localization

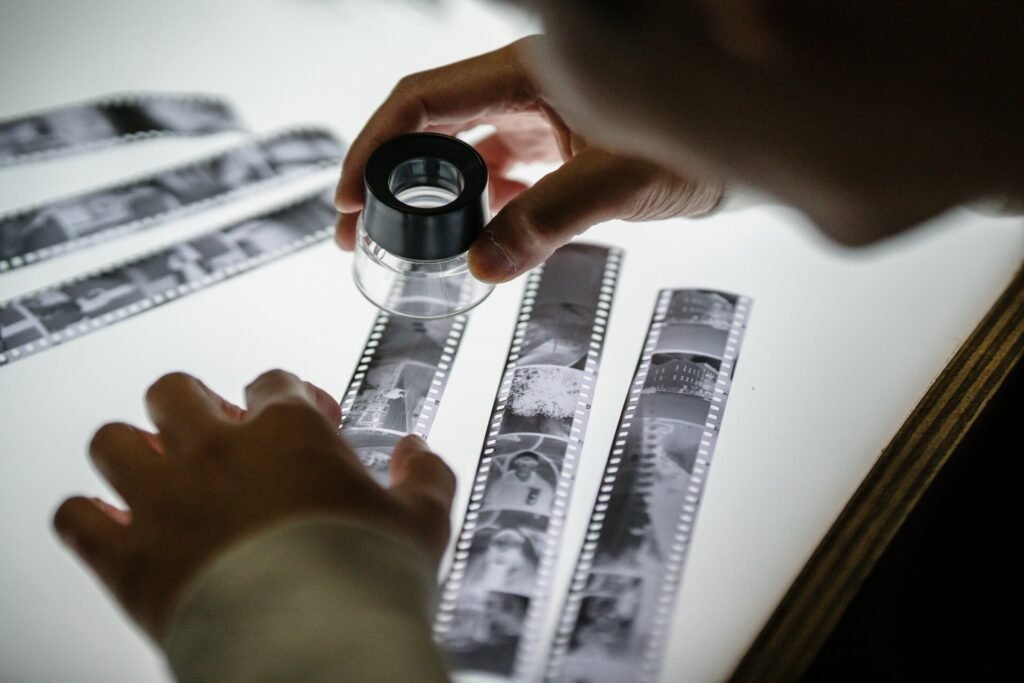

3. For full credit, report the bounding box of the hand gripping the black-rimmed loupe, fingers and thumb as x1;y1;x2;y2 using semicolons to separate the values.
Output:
335;38;722;282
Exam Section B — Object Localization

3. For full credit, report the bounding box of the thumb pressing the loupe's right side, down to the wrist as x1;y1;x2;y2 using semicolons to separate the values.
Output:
469;147;722;283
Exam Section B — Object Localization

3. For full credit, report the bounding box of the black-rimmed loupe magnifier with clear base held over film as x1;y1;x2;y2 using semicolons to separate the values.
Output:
353;133;494;318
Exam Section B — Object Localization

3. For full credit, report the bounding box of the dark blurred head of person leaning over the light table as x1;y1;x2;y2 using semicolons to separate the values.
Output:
522;0;1024;245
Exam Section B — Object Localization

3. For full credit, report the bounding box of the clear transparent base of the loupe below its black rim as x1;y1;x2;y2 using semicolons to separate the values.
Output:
352;215;494;318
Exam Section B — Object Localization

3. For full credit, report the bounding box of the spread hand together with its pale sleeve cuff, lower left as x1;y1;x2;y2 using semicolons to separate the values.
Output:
54;371;455;683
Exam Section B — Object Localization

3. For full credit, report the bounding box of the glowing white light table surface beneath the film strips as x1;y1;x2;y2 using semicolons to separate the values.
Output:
0;0;1024;683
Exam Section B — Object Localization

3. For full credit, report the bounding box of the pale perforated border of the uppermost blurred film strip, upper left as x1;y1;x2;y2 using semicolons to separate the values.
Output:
0;92;245;169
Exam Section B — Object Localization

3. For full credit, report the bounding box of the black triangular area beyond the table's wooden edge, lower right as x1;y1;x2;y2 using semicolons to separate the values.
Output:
805;362;1024;681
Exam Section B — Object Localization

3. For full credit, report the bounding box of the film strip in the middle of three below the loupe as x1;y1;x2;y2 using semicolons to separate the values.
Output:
434;243;622;676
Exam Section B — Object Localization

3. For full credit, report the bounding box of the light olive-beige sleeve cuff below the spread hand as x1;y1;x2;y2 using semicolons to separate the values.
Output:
163;517;449;683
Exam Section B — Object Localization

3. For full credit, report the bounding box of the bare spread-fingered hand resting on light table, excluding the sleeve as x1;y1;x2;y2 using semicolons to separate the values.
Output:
53;371;455;642
